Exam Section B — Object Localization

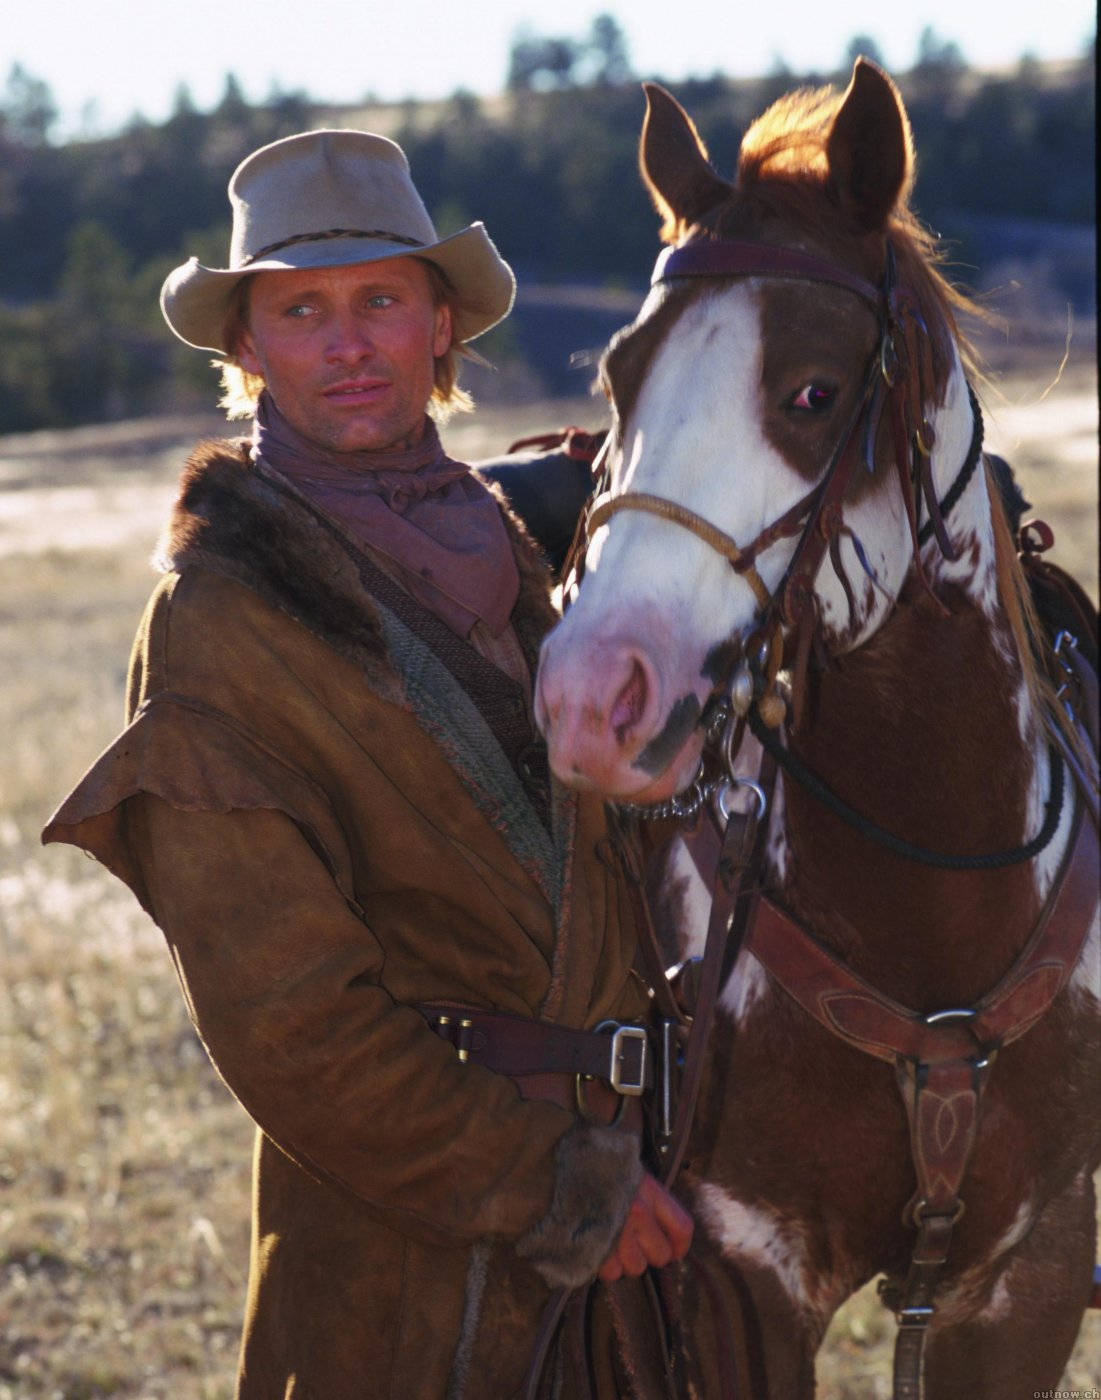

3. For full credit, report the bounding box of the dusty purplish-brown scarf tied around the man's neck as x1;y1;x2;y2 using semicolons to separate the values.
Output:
252;391;520;637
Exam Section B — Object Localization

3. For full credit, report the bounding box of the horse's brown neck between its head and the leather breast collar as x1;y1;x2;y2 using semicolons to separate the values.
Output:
782;448;1046;1009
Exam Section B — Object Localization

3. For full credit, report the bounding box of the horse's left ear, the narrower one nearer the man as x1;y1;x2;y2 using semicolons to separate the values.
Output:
639;83;731;242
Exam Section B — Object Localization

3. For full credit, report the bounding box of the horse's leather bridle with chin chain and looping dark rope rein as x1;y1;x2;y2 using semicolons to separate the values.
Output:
584;231;1065;869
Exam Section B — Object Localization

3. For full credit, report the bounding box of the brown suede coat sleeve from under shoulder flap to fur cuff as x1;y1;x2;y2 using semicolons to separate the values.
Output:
113;794;639;1275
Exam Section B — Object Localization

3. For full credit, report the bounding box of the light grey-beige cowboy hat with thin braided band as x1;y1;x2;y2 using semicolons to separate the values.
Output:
161;130;515;354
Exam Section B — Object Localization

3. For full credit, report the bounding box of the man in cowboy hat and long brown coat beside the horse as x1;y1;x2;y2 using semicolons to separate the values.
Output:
45;130;691;1400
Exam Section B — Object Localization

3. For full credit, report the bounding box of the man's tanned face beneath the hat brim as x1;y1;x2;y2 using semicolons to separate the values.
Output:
237;258;451;452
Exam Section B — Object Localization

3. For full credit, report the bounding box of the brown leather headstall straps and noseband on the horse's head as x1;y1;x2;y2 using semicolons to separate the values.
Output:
573;239;963;728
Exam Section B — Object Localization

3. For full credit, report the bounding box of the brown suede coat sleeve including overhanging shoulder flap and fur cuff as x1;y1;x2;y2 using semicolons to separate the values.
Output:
43;568;639;1275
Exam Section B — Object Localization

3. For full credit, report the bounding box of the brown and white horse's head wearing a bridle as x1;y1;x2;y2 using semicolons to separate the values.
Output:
536;60;978;801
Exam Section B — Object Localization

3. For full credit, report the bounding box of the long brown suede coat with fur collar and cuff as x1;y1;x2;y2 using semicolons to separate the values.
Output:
43;444;644;1400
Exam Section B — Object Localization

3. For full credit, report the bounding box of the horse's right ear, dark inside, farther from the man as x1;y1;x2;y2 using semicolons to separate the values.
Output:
826;59;913;232
